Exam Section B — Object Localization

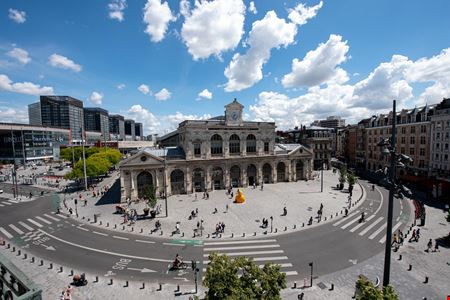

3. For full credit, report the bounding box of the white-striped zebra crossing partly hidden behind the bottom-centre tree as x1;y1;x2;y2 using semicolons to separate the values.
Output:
203;239;298;276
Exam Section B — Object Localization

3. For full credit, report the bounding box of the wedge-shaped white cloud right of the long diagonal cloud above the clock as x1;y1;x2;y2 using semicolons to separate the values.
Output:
282;34;349;87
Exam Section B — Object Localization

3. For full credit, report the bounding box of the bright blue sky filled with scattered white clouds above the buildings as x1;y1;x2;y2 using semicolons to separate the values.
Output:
0;0;450;135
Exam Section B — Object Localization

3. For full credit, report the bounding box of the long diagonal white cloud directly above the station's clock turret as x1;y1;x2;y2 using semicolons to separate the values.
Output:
224;11;297;92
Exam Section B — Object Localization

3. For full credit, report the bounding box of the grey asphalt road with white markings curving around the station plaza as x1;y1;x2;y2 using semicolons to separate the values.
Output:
0;182;410;283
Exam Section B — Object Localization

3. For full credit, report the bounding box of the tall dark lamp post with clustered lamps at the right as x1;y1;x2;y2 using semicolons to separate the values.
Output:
377;100;412;287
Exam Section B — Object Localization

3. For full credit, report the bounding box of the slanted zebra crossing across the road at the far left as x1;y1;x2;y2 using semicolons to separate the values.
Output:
0;214;67;239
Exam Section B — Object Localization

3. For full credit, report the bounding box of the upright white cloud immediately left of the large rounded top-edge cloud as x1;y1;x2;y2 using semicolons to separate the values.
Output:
144;0;176;43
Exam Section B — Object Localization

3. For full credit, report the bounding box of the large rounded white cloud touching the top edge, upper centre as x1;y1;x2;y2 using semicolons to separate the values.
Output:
180;0;245;60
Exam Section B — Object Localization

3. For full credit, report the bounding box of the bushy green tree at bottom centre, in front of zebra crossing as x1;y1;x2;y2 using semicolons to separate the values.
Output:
203;253;286;299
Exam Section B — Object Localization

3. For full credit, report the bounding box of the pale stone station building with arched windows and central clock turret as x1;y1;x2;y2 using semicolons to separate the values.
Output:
120;100;313;201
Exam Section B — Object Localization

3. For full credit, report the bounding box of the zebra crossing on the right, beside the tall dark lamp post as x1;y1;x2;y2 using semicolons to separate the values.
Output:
333;210;403;244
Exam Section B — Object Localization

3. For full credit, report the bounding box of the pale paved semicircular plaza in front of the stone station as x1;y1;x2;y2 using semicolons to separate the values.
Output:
61;171;365;239
